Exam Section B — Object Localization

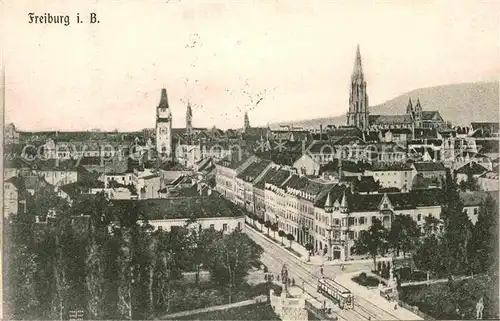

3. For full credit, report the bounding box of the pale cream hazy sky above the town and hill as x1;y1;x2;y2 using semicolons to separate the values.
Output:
2;0;500;130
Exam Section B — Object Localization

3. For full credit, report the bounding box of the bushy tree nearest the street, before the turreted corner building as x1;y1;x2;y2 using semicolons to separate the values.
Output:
354;218;387;269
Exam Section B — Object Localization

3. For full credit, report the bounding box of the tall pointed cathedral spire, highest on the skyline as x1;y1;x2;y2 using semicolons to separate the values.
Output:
347;45;370;130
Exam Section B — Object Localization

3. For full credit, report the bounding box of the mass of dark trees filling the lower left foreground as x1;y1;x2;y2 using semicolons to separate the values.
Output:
3;190;262;320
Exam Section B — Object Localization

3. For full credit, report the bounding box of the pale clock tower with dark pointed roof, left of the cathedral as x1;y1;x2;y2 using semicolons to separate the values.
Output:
156;88;172;157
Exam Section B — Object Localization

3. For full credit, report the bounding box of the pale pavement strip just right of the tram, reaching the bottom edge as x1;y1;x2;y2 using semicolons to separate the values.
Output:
335;272;423;320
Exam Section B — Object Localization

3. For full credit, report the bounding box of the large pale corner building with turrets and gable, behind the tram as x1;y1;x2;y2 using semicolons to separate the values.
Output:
314;185;443;260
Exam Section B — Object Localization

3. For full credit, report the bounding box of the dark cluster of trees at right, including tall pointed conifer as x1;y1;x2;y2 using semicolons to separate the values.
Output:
354;173;498;276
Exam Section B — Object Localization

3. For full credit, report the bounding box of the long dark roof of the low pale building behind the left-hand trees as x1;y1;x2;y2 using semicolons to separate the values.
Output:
112;194;243;220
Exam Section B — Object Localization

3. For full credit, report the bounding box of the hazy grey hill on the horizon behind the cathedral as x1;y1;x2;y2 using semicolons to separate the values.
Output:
271;81;500;128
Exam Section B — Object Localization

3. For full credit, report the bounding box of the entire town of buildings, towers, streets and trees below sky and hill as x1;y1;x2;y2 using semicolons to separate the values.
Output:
3;41;500;320
